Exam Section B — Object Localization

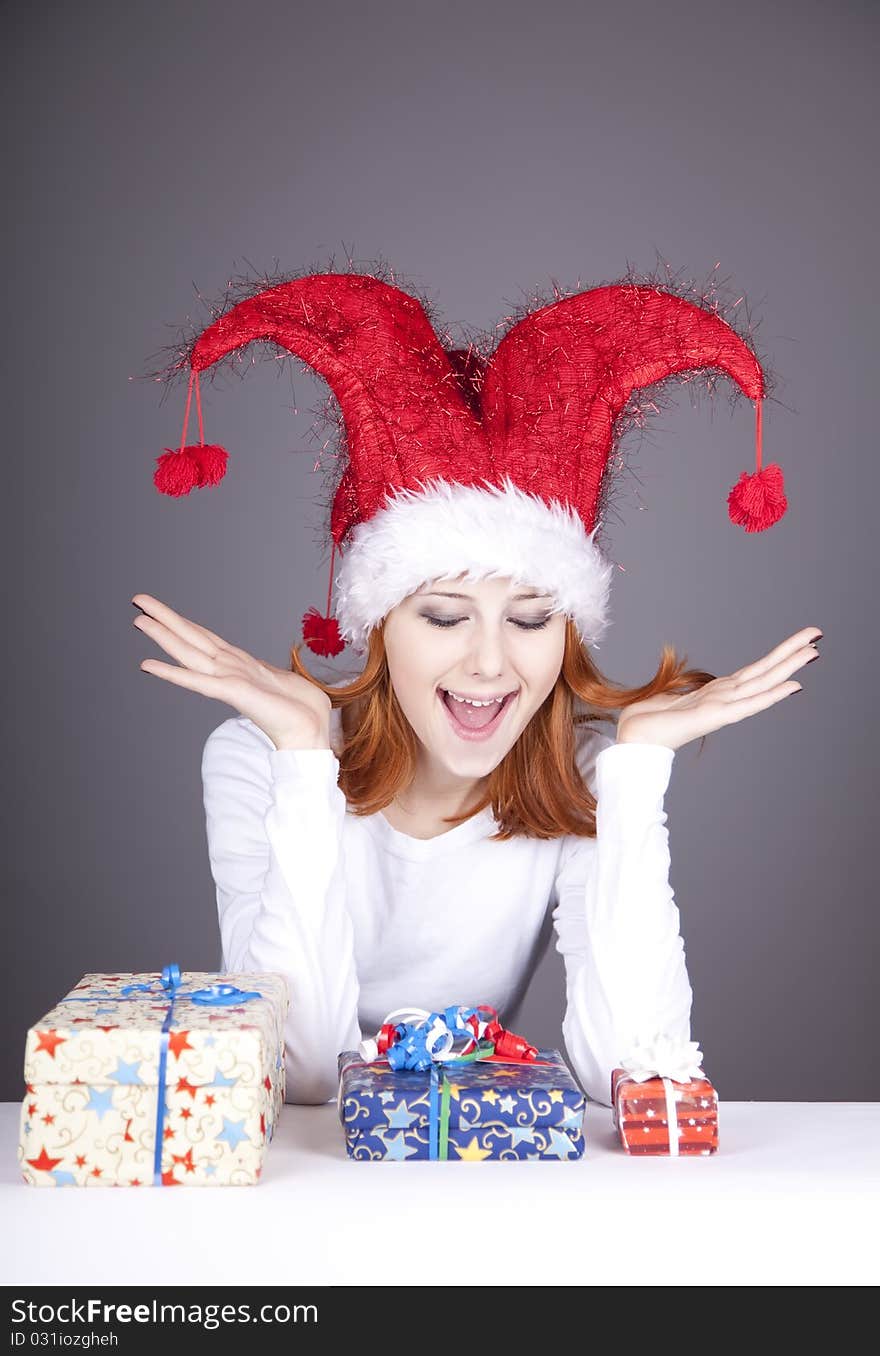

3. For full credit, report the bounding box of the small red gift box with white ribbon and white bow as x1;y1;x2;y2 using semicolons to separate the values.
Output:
612;1036;719;1158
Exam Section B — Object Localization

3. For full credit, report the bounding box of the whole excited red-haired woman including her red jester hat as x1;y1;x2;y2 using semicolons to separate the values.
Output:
133;261;820;1105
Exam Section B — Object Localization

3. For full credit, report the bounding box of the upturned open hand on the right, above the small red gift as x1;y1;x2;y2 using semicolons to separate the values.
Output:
617;626;822;749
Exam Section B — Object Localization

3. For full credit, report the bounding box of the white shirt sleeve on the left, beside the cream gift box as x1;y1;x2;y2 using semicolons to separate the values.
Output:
202;717;361;1104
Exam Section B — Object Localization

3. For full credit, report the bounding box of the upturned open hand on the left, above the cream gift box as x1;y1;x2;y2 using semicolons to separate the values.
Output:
132;594;332;749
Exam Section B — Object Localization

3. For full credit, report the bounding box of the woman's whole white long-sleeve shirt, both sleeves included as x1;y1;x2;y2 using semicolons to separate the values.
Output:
202;711;692;1106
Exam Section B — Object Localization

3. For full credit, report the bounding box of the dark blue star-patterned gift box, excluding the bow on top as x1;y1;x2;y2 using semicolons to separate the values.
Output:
338;1050;584;1162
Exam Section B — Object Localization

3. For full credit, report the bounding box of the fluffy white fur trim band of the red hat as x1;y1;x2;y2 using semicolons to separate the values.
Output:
329;477;614;654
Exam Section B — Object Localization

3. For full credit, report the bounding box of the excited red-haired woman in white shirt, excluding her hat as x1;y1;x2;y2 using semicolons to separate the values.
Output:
133;579;820;1105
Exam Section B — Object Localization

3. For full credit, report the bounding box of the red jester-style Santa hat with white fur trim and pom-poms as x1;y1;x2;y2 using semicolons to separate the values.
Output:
147;260;786;655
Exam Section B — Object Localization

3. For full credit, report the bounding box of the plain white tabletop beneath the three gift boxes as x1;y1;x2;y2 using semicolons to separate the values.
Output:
0;1102;880;1287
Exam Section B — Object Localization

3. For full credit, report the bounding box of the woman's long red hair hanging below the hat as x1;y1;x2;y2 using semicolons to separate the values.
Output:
290;618;715;841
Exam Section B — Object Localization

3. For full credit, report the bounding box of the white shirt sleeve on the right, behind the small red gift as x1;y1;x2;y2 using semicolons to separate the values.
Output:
553;731;693;1106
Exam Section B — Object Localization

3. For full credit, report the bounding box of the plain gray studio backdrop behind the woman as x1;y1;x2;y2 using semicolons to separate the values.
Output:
0;0;880;1100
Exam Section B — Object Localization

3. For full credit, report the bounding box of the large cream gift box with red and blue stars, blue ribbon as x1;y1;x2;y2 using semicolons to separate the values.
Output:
18;964;289;1187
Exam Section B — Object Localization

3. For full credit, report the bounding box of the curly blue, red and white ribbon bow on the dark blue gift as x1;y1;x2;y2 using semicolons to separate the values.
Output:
349;1005;549;1159
